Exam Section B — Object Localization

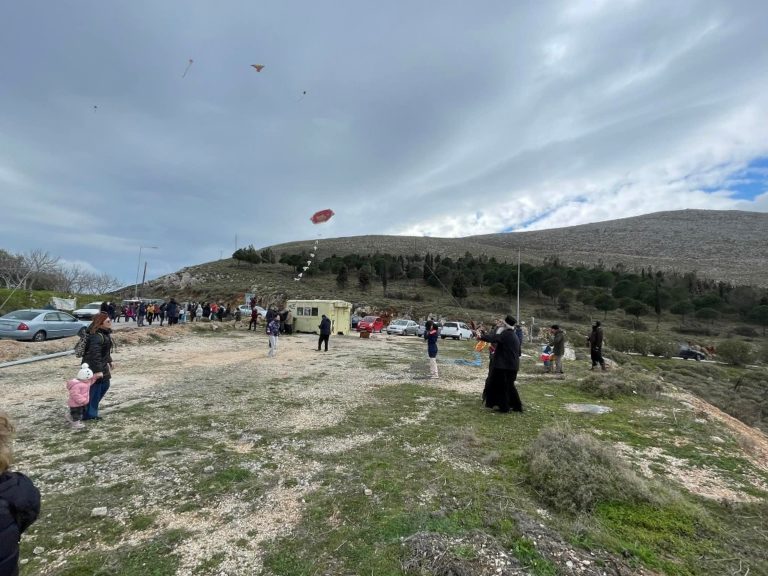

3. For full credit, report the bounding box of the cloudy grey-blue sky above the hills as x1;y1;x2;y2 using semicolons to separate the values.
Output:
0;0;768;285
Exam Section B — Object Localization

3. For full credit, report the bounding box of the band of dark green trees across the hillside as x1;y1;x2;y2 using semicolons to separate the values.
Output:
233;249;768;334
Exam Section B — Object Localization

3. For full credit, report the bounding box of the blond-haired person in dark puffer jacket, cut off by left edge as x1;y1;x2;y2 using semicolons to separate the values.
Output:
0;412;40;576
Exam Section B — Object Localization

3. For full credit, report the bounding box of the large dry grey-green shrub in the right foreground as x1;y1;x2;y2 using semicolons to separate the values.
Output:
526;426;654;514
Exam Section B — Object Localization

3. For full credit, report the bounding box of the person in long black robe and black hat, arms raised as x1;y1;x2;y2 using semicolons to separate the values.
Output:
479;316;523;412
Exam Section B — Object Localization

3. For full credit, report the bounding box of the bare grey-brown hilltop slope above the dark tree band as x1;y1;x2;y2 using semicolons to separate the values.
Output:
270;210;768;287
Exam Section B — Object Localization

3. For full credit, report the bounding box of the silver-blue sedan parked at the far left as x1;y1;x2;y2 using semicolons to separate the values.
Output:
0;309;90;342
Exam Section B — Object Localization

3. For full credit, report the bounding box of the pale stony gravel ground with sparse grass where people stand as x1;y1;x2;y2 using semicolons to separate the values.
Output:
0;324;768;575
